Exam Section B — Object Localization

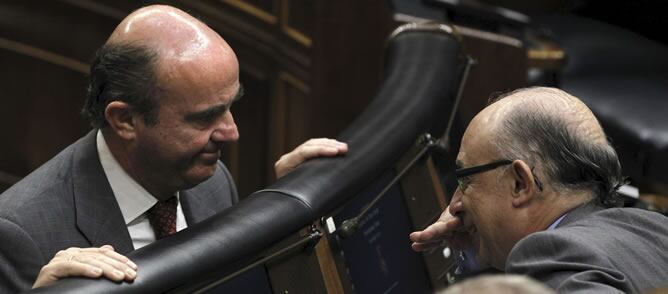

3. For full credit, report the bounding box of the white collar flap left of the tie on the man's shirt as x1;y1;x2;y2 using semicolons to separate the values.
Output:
97;130;158;224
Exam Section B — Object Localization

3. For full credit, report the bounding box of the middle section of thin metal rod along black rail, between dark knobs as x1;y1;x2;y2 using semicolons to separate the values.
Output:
336;133;439;239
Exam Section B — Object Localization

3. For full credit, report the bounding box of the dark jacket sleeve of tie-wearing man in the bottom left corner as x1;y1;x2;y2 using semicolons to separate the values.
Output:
0;218;45;293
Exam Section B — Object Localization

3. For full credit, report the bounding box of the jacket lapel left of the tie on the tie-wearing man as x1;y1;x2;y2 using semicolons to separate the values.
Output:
72;129;134;254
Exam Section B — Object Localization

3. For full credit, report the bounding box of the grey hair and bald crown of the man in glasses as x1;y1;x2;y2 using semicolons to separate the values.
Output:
491;88;625;207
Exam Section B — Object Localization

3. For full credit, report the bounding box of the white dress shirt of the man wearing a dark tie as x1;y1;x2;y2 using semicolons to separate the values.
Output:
97;130;188;249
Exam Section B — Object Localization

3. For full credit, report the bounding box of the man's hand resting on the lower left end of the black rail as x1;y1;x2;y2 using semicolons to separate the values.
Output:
33;245;137;288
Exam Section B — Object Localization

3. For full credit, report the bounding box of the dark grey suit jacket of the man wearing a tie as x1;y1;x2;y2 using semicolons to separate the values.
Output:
0;130;238;293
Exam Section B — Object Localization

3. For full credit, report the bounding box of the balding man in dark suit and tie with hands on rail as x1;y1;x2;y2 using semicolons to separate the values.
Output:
0;5;347;293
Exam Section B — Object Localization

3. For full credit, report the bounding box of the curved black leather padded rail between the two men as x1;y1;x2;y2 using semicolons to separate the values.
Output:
35;25;465;293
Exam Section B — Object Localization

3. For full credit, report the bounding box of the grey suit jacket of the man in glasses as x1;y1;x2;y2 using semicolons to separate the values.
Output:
506;204;668;293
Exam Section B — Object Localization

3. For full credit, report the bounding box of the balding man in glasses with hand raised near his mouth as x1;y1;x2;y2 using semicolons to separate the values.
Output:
410;88;668;293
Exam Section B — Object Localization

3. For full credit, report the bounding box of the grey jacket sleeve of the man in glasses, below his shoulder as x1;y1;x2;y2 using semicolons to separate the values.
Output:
506;231;633;293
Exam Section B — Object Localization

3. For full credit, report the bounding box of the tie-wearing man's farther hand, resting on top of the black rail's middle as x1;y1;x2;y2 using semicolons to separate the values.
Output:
274;138;348;178
